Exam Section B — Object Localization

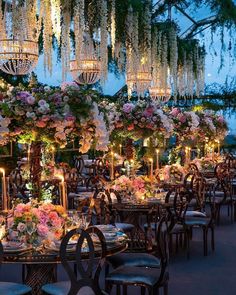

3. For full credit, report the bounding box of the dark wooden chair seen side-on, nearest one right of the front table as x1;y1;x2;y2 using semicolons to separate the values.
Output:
106;217;169;295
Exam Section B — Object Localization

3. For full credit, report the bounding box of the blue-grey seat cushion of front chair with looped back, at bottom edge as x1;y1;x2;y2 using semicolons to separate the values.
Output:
42;281;106;295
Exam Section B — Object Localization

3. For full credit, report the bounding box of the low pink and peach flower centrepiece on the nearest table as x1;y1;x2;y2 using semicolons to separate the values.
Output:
7;201;67;245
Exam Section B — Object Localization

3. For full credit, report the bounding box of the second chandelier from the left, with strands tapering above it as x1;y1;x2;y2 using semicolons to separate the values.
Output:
70;40;101;85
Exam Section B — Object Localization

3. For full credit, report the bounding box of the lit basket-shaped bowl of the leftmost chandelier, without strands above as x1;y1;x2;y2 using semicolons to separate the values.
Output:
0;39;39;75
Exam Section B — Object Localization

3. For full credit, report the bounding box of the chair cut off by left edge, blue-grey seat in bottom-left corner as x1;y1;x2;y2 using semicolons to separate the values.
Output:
0;241;32;295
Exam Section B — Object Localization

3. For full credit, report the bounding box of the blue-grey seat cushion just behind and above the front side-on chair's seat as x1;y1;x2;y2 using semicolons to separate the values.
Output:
107;253;161;268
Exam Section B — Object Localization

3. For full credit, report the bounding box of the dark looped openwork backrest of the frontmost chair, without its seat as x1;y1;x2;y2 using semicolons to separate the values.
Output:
60;227;107;295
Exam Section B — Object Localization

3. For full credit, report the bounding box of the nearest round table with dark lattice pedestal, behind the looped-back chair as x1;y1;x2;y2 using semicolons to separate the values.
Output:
2;232;127;295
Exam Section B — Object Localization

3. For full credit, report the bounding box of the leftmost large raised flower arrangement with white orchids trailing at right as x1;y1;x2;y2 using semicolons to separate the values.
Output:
0;83;109;152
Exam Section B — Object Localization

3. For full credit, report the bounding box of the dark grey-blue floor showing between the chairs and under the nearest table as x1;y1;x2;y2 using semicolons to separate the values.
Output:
0;209;236;295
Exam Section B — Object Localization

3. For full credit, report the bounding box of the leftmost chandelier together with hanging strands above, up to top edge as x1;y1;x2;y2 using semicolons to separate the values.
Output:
0;0;40;75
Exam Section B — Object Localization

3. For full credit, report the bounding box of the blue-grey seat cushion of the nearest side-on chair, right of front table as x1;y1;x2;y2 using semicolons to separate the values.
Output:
106;266;169;286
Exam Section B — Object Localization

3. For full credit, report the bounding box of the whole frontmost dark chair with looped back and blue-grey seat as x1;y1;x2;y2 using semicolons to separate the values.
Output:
42;227;107;295
